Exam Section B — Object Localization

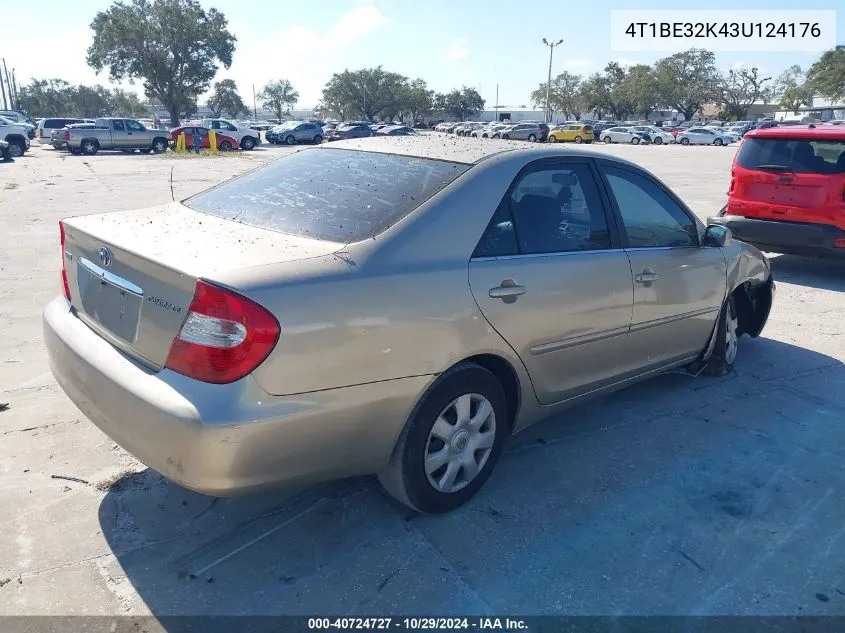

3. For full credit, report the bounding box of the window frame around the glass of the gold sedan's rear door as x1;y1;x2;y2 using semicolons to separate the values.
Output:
470;156;624;260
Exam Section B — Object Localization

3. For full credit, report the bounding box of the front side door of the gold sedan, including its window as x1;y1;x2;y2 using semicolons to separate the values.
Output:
600;161;727;370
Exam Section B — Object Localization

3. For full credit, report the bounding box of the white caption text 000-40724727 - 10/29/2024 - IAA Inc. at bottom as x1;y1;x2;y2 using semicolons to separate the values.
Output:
308;617;528;631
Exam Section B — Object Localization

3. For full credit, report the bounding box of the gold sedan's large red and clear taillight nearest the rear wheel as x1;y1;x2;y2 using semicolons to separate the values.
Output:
165;280;281;384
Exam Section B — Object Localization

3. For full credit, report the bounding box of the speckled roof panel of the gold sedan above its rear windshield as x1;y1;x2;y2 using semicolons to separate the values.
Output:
310;134;642;169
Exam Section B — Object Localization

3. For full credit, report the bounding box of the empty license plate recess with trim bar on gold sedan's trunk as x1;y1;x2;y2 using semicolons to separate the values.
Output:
76;257;144;343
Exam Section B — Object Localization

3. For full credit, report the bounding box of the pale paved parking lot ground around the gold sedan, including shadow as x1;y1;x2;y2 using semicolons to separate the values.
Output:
0;136;845;630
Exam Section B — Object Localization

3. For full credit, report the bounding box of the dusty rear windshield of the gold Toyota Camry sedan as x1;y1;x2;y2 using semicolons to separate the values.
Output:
185;149;469;243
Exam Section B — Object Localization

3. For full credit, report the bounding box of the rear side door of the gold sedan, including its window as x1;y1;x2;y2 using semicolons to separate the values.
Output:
469;159;633;404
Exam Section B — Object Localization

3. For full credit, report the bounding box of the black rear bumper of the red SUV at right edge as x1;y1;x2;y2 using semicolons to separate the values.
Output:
707;215;845;257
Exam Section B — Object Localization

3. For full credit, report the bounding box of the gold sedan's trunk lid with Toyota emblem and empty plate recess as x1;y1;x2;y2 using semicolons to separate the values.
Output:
63;203;341;369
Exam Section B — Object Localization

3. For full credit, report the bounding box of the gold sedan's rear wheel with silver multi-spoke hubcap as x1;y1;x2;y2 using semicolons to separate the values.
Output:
379;363;508;513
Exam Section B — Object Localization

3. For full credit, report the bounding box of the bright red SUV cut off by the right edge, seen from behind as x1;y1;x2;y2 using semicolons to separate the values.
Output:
710;125;845;256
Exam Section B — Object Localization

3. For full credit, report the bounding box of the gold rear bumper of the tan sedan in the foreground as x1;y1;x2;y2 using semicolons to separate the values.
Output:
43;297;430;496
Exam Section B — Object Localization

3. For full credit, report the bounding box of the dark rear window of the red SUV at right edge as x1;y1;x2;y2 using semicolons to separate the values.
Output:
736;137;845;174
